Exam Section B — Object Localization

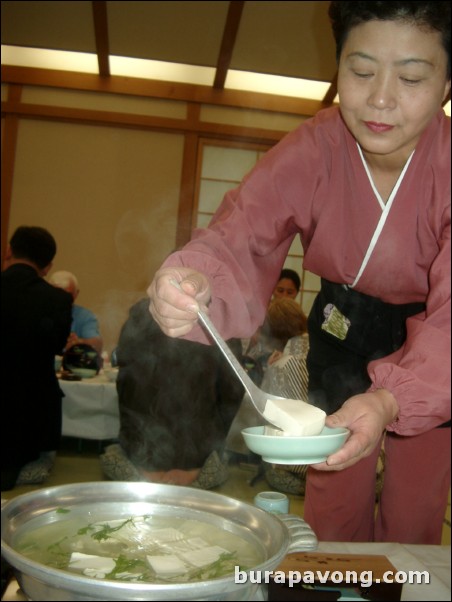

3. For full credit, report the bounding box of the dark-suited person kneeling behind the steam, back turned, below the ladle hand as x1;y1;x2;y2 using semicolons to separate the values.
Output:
101;298;243;489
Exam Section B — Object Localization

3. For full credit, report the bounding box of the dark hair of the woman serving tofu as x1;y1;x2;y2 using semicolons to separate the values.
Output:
329;1;451;79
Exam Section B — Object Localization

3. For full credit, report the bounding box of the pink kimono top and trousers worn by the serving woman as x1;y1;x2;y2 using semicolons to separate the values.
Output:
165;108;450;543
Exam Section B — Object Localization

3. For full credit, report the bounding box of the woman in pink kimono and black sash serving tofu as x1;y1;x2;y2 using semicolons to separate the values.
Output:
148;2;450;544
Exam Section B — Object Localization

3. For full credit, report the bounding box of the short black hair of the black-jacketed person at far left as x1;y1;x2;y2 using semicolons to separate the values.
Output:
9;226;56;269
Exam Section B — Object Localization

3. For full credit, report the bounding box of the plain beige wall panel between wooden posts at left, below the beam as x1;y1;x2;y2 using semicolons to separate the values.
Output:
9;120;183;351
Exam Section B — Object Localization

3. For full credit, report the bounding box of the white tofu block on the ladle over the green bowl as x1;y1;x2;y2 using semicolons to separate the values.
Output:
264;399;326;437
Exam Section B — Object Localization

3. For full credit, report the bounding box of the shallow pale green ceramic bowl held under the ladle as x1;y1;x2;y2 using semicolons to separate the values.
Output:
242;426;350;464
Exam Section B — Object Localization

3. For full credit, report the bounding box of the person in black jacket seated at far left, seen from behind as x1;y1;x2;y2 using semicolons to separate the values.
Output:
1;226;72;491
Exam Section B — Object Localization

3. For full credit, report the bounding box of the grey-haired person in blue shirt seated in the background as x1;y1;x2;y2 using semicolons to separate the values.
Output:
49;270;103;355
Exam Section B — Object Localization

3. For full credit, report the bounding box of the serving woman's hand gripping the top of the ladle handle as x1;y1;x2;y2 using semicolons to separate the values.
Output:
147;267;211;337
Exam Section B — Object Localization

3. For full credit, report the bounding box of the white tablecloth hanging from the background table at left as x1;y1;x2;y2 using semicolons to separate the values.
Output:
60;374;119;440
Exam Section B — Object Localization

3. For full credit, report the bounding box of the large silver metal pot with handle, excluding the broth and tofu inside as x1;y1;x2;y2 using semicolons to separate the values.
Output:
1;482;317;601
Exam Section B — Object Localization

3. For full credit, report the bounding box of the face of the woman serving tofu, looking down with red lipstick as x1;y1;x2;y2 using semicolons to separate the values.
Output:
338;21;450;165
